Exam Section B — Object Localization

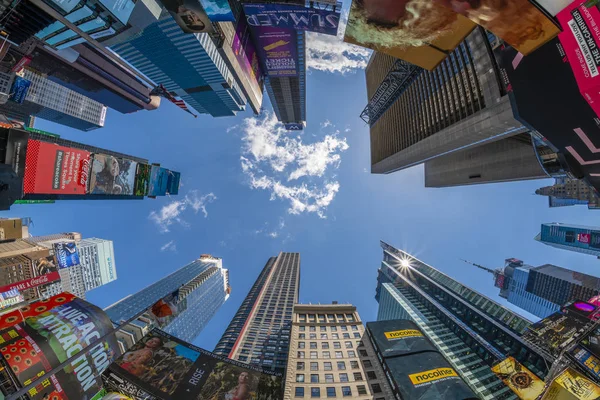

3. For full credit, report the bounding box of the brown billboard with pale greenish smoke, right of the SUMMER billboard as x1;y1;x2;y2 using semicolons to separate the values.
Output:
344;0;476;70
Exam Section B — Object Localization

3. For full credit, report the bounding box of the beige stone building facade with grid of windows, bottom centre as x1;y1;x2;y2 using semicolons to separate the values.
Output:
283;302;373;400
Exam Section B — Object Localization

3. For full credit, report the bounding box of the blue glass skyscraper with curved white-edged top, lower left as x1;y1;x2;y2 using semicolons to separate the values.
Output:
106;255;231;347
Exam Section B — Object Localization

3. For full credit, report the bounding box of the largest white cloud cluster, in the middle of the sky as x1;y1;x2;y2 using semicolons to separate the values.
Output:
241;113;348;218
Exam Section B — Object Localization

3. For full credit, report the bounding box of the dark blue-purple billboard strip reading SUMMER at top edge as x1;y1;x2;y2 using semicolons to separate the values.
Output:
244;3;342;36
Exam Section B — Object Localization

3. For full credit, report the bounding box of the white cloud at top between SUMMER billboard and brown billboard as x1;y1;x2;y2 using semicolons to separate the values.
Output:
306;12;371;74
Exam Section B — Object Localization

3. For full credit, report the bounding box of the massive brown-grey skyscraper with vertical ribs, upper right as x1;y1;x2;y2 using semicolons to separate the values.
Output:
361;29;564;187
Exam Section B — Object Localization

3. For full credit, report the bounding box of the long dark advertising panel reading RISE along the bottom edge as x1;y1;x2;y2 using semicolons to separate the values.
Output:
103;329;283;400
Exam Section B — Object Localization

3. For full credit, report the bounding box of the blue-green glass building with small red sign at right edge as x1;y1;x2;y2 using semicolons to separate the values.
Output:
535;222;600;258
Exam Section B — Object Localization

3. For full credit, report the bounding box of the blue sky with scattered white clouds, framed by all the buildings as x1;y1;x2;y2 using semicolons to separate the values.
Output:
2;28;600;350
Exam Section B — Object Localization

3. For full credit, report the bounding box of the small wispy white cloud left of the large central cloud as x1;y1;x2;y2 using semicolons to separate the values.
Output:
148;190;217;233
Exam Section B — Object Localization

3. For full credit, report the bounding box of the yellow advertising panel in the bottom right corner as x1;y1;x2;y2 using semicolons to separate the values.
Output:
541;368;600;400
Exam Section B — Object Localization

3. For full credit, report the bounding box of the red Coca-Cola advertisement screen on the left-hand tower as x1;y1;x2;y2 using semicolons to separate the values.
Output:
23;140;90;194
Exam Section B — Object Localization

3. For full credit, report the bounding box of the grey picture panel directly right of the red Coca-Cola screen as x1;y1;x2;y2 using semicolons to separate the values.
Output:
89;154;137;195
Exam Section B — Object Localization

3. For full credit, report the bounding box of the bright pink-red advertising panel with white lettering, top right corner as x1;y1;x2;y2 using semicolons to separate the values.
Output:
556;0;600;116
